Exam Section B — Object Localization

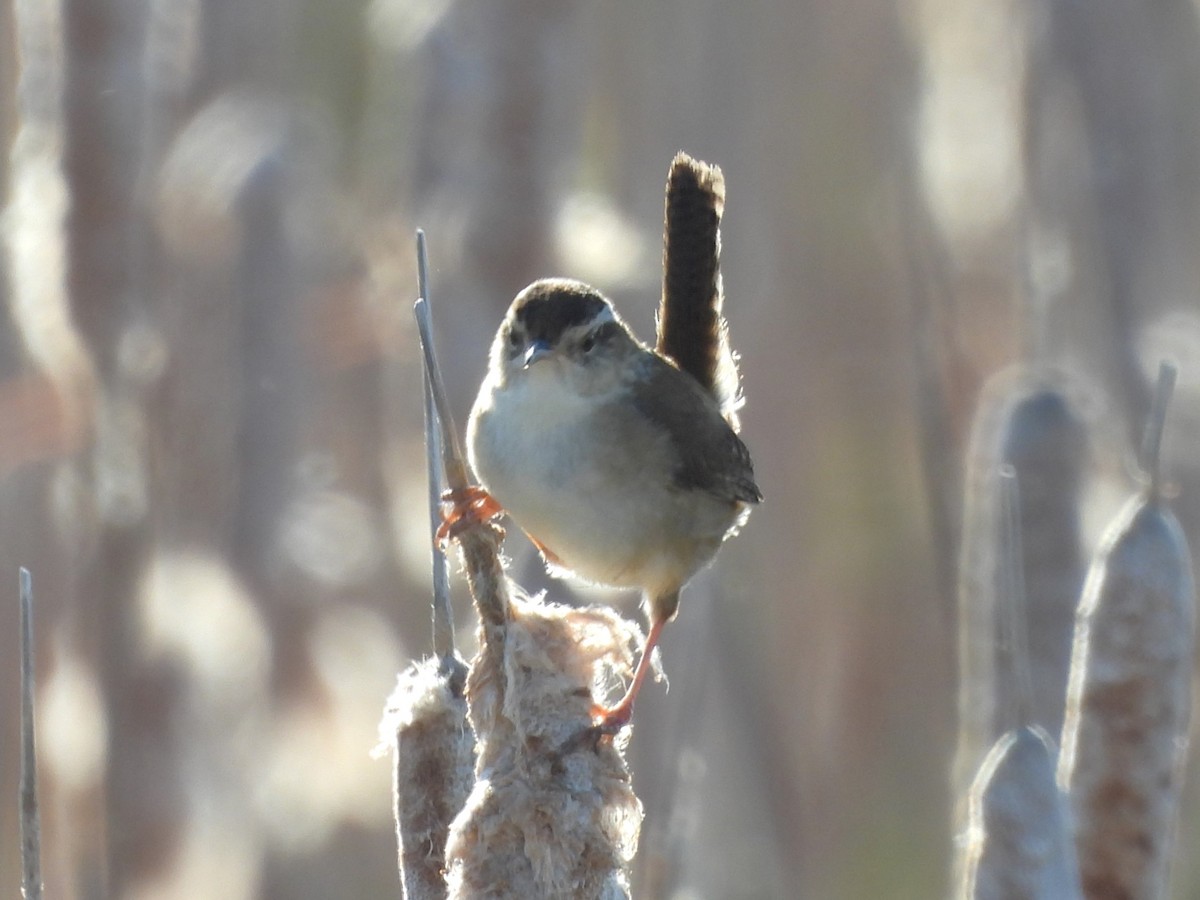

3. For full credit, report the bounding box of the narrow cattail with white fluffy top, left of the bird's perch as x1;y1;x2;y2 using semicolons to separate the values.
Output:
380;656;475;900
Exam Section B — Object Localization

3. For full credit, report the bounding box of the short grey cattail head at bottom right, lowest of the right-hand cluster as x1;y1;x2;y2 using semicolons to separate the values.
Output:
958;726;1084;900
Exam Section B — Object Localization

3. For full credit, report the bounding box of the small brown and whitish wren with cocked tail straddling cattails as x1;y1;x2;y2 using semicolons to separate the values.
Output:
451;154;762;733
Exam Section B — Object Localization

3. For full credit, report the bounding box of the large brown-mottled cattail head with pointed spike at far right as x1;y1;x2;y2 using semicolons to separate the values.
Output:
1058;366;1195;898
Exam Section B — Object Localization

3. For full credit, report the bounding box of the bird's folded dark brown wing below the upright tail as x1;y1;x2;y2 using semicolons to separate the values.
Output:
632;354;762;503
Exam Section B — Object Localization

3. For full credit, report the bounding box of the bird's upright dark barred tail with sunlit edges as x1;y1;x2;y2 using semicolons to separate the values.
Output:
656;152;739;428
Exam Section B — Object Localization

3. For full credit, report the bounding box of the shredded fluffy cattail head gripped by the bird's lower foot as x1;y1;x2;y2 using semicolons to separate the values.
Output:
448;598;642;900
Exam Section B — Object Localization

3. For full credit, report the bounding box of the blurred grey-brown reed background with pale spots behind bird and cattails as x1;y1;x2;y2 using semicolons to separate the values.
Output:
0;0;1200;900
